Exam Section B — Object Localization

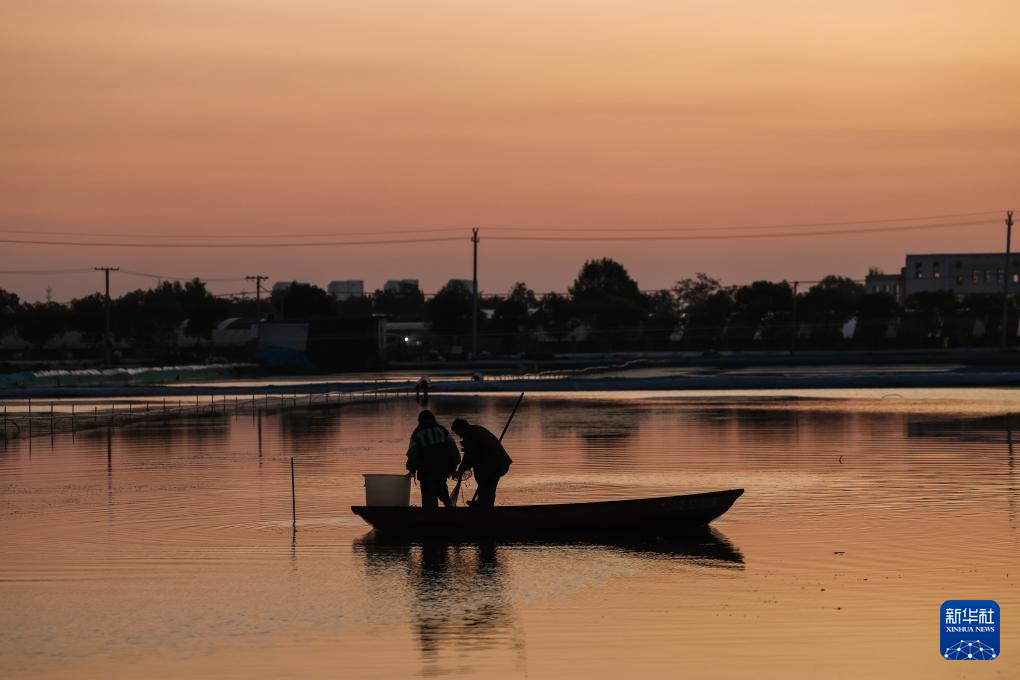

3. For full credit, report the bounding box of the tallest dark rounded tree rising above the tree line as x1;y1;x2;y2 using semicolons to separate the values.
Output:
569;258;648;347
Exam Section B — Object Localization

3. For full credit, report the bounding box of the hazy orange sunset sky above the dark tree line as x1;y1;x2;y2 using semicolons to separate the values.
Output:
0;0;1020;301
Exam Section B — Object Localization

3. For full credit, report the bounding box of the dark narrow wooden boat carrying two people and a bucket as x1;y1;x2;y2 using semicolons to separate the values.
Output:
351;488;744;536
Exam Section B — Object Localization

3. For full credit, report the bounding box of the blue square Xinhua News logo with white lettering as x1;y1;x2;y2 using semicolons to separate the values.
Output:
938;599;1002;661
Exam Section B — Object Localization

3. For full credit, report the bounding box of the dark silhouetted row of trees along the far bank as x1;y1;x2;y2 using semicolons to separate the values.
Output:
0;258;1016;358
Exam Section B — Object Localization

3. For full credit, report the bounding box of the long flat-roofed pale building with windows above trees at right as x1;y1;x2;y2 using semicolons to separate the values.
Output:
864;253;1020;303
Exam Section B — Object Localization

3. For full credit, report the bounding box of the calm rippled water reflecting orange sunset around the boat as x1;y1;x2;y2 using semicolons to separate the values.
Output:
0;389;1020;678
